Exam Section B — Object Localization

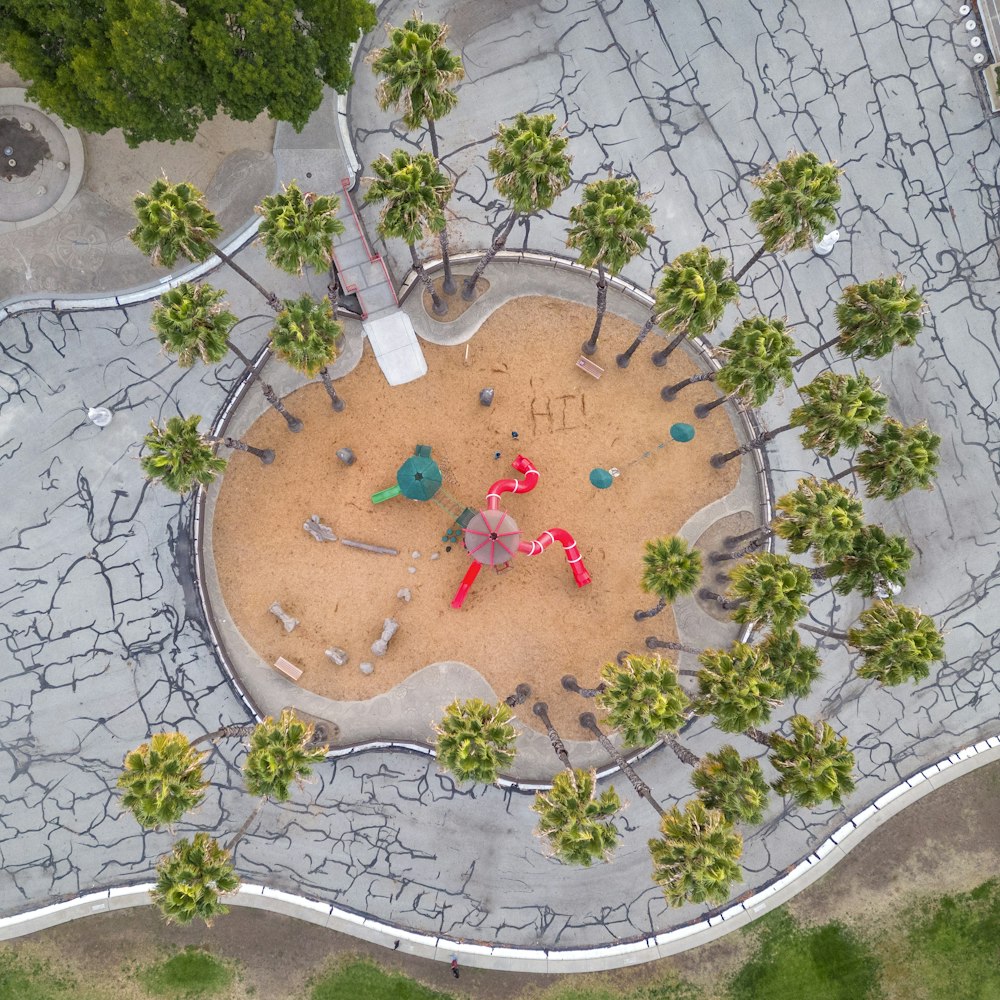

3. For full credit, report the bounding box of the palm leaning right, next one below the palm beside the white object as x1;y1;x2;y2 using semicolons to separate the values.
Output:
795;274;927;368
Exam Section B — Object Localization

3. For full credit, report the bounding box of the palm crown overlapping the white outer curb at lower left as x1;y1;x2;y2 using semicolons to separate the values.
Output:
150;833;240;926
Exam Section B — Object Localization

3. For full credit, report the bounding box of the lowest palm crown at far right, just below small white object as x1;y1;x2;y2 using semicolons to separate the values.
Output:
847;601;944;685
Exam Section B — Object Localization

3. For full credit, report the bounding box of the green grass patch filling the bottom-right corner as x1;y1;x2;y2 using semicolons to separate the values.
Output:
885;879;1000;1000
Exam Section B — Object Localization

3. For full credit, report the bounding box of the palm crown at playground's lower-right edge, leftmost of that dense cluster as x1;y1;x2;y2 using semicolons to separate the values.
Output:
596;656;690;747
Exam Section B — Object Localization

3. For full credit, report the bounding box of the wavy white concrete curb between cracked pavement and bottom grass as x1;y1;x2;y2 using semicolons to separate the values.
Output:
0;736;1000;974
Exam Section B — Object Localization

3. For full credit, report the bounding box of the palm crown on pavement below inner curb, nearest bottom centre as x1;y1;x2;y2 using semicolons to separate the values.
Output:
531;768;621;867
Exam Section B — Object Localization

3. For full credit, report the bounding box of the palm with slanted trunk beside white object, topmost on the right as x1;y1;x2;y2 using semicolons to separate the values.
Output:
735;152;843;281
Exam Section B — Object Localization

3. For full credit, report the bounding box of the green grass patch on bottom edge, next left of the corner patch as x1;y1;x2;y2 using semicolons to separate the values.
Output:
728;910;881;1000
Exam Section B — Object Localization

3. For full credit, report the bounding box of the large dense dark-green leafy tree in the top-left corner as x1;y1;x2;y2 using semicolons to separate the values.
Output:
0;0;375;147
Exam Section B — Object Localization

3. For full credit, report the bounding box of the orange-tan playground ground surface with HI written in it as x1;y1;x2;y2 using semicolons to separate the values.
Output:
213;297;739;739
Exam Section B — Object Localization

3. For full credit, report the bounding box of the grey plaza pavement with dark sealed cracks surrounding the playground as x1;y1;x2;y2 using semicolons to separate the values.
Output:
0;0;1000;949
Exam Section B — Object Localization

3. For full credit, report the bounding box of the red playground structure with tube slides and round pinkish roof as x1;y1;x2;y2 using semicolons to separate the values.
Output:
451;455;590;610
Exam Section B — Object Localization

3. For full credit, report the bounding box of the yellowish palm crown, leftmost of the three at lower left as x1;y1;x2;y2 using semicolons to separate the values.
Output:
118;733;207;829
